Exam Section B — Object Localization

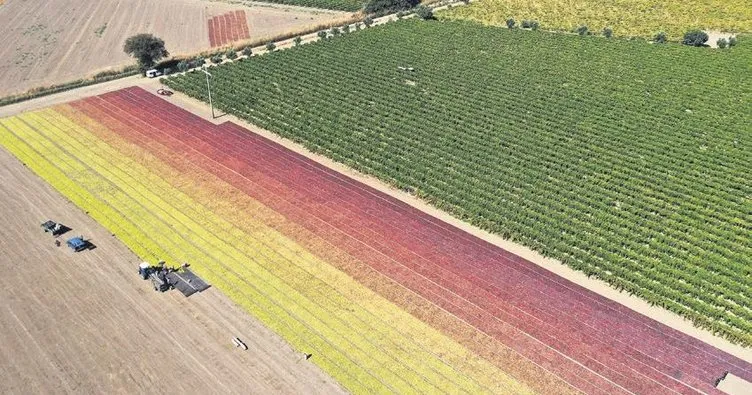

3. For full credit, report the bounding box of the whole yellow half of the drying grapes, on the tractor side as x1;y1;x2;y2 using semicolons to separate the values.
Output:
2;95;526;393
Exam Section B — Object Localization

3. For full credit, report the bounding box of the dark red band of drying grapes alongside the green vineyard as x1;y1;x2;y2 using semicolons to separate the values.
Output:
101;90;747;393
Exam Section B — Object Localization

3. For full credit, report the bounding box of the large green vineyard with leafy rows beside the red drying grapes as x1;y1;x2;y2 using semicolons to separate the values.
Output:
167;20;752;345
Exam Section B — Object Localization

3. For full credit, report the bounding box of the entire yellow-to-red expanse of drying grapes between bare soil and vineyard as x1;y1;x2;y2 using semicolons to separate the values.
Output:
0;83;752;394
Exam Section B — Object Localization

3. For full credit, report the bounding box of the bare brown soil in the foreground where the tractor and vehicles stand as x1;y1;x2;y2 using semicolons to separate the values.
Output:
0;150;342;394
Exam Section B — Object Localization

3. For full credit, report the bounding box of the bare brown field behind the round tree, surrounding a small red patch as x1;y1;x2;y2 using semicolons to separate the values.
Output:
0;0;346;96
